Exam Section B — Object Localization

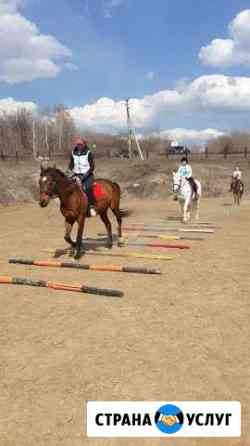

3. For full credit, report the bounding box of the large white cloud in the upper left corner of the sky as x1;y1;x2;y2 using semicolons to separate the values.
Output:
0;0;71;84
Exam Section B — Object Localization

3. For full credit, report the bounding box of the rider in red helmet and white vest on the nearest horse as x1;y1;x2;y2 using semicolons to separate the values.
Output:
69;138;96;217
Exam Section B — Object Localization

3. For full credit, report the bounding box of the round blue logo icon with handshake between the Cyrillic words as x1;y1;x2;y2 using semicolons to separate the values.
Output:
155;404;184;434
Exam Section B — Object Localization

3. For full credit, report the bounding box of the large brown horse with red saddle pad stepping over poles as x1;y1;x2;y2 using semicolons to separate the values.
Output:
39;167;128;259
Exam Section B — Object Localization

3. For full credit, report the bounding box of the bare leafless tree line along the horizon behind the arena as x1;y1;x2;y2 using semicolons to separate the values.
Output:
0;105;250;161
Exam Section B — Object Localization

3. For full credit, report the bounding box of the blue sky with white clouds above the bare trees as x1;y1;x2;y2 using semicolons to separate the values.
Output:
0;0;250;143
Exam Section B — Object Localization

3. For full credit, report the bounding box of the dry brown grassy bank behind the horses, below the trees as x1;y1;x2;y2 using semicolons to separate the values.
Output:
0;157;250;204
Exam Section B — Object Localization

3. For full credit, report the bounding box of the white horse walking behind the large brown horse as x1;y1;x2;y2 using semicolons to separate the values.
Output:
173;172;201;223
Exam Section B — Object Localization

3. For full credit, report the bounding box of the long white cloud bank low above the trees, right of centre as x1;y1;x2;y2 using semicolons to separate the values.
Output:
69;75;250;131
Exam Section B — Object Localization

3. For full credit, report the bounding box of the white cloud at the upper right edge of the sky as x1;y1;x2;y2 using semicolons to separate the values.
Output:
199;9;250;67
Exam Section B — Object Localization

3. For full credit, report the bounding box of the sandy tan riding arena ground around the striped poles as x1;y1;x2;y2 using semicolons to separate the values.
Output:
0;197;250;446
